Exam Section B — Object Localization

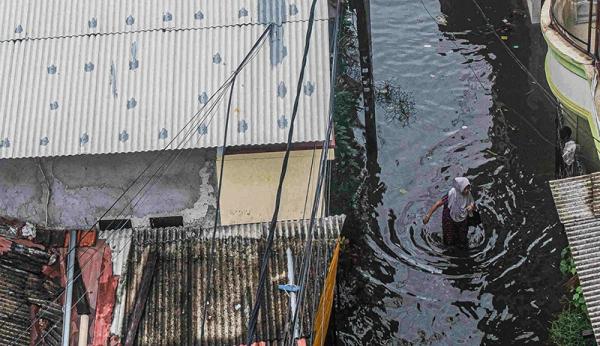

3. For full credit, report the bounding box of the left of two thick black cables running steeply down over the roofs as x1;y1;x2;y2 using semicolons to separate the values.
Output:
246;0;324;345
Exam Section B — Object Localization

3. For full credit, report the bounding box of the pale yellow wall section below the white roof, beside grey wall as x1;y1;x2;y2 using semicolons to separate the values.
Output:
217;150;333;225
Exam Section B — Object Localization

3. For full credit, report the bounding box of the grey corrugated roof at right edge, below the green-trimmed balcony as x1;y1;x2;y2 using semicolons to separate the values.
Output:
550;173;600;343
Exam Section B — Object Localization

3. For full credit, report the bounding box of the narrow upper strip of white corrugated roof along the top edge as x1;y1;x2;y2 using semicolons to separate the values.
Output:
0;0;328;41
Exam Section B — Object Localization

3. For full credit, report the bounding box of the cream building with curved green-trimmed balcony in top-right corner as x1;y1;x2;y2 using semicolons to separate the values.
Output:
541;0;600;171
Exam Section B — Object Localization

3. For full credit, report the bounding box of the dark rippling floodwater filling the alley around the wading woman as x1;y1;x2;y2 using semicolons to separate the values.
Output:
333;0;566;345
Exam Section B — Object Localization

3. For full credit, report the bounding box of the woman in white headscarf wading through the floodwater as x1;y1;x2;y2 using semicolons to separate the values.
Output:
423;177;476;247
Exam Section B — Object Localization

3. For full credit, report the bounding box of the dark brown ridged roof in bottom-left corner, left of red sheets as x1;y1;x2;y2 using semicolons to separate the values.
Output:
0;239;62;346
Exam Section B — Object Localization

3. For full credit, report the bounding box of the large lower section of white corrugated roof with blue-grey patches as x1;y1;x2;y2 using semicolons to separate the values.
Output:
0;0;330;158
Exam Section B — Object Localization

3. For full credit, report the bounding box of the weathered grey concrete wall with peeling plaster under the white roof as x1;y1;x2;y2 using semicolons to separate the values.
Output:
0;149;216;228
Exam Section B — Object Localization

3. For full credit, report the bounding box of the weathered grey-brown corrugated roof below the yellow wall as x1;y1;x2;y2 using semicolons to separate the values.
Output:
107;216;344;345
